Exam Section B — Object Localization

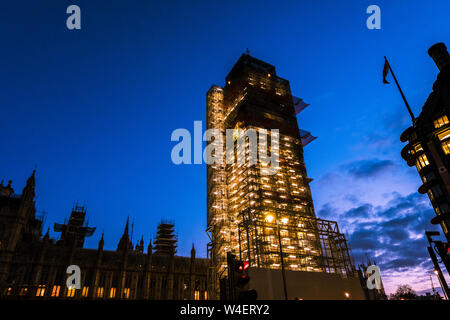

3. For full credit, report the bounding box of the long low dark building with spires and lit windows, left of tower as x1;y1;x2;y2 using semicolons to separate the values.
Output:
0;172;209;300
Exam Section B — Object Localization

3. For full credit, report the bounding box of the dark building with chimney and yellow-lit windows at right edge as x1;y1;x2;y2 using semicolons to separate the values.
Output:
400;43;450;241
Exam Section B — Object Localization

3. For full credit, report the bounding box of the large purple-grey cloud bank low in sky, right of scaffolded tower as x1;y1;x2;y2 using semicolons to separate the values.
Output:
318;192;442;291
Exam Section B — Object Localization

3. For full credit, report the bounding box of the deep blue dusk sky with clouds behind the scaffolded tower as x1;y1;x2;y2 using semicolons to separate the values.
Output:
0;0;450;292
